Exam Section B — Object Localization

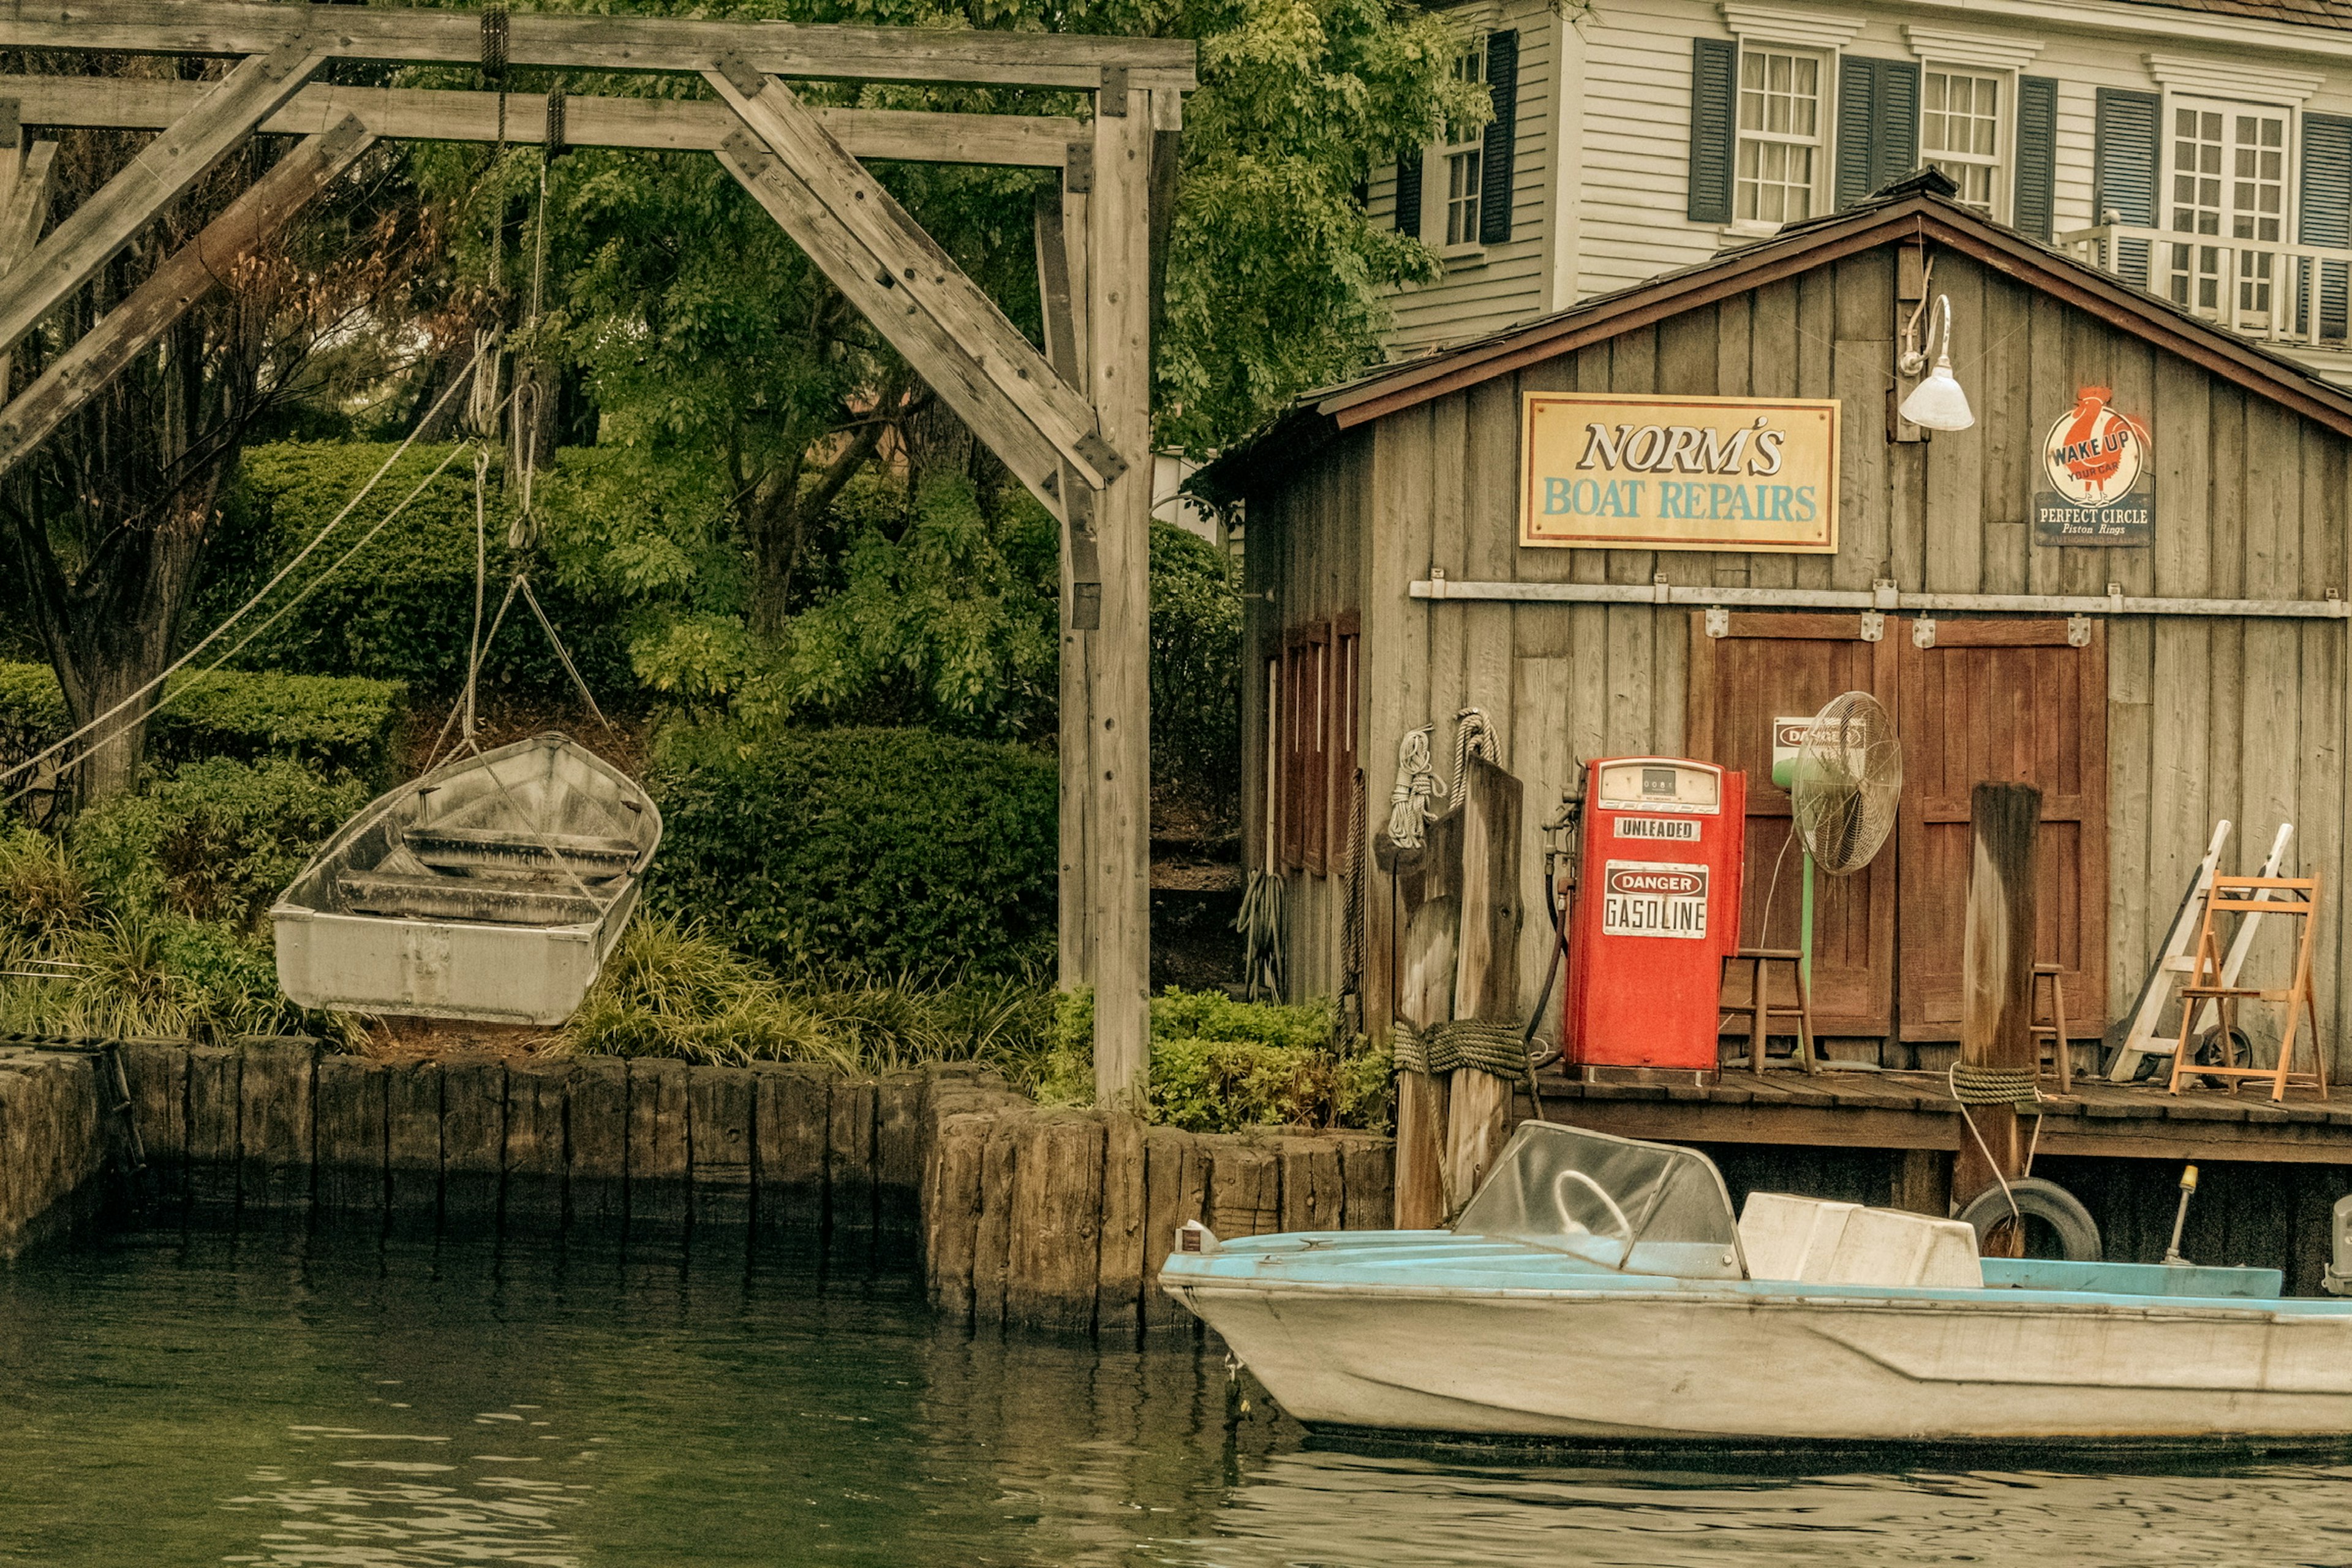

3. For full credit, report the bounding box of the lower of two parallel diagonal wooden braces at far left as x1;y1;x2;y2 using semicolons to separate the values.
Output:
0;115;376;472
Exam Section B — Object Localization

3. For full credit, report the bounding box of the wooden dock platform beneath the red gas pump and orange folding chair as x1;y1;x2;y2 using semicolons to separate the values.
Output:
1517;1067;2352;1166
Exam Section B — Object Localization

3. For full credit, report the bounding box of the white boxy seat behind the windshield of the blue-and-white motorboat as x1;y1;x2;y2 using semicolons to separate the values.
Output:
1741;1192;1985;1291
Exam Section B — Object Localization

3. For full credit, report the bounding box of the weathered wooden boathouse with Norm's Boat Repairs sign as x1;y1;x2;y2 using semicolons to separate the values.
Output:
1207;174;2352;1269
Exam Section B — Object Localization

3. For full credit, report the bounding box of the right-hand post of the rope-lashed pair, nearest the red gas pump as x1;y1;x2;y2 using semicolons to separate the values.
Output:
1447;757;1524;1220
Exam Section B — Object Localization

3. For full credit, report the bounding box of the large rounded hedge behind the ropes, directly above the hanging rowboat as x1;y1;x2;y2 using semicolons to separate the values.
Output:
188;442;635;701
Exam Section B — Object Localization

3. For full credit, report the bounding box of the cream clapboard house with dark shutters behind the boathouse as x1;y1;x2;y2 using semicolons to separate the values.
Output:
1369;0;2352;381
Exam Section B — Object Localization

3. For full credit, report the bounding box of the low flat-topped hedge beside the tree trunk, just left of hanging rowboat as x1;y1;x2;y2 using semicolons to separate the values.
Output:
0;663;402;788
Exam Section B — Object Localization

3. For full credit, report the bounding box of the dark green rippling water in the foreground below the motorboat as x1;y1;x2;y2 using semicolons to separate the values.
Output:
0;1232;2352;1568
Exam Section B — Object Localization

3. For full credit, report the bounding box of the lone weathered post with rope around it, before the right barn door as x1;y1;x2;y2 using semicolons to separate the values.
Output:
1952;783;2041;1256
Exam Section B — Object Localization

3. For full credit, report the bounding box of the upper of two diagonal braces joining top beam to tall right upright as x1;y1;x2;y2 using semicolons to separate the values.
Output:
706;59;1126;489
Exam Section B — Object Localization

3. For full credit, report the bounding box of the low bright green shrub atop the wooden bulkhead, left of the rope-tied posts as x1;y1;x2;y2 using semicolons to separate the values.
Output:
1039;987;1390;1133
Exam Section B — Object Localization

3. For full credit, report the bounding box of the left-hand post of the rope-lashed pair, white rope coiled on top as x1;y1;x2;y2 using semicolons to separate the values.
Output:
1374;816;1461;1229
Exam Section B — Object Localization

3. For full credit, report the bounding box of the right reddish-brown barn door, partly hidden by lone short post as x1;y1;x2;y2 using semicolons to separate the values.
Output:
1889;620;2108;1039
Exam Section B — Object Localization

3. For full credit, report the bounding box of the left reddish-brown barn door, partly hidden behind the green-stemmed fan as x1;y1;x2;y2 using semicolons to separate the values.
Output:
1684;611;1905;1037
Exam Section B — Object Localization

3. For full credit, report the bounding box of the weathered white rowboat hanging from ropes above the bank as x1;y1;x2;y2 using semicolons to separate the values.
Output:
271;733;661;1025
